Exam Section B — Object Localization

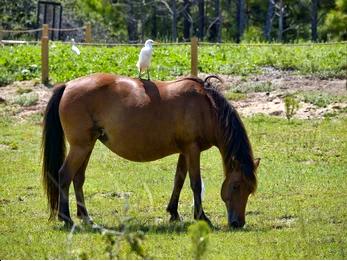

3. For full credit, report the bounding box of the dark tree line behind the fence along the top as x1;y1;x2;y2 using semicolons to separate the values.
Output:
0;0;347;43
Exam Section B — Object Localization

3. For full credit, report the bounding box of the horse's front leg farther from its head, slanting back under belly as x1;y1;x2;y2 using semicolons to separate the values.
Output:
166;154;187;221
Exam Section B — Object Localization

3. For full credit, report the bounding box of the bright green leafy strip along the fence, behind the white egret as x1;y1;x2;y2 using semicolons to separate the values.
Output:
0;43;347;86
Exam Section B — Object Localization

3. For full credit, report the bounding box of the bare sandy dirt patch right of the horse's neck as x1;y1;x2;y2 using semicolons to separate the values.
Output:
199;68;347;119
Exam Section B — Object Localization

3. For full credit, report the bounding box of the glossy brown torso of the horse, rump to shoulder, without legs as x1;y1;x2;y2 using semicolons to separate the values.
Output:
60;74;218;161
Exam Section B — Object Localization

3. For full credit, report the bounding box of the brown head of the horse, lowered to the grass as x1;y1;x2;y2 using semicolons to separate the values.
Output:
221;159;260;228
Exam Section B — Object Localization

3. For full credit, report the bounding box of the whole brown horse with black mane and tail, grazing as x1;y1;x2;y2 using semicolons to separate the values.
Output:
42;73;259;227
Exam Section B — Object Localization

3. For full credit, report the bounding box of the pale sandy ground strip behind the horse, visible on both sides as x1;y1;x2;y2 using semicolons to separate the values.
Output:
0;69;347;119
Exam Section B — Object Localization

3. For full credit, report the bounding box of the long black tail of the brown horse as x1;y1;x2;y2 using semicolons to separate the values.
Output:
41;84;65;219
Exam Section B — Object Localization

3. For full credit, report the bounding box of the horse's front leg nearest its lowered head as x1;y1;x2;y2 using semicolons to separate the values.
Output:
187;144;212;226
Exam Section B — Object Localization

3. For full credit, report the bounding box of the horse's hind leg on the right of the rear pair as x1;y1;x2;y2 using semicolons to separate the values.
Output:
73;152;93;224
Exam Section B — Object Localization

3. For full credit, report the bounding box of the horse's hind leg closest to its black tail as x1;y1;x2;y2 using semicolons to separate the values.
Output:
58;145;90;226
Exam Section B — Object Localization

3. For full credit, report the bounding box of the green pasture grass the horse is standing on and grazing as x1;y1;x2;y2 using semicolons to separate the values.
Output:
0;109;347;259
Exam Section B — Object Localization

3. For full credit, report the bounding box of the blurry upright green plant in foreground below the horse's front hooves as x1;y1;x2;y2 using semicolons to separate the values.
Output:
188;220;211;260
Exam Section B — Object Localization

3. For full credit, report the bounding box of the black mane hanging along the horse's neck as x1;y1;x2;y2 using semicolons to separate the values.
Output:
185;75;257;192
